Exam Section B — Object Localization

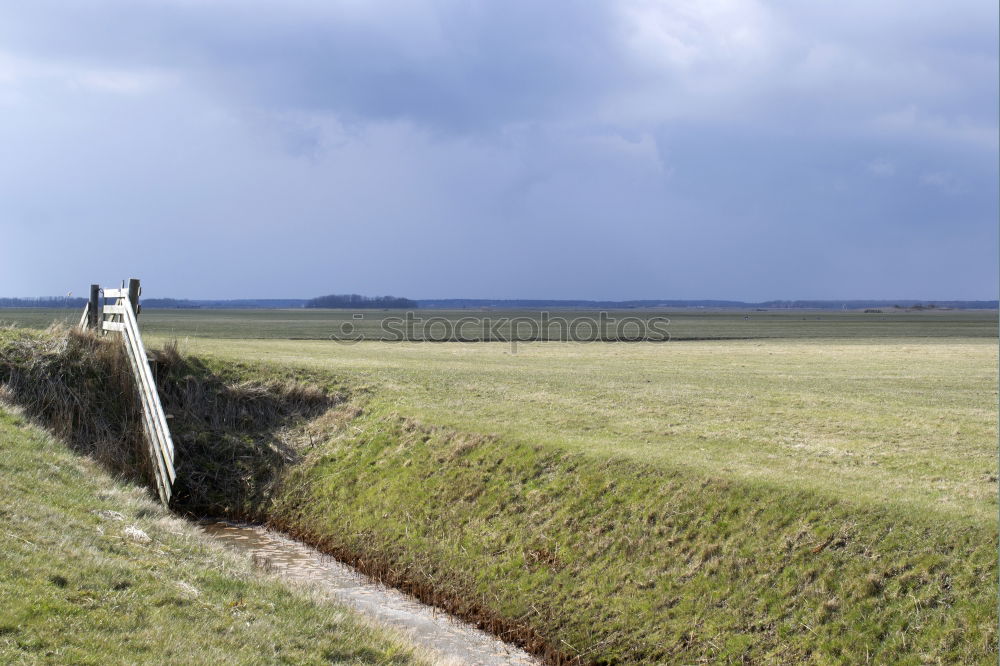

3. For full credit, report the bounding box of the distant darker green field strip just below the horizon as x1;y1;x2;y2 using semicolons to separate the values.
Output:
0;308;997;340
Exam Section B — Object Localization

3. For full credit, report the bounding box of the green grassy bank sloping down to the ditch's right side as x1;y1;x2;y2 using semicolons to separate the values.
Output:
270;396;997;664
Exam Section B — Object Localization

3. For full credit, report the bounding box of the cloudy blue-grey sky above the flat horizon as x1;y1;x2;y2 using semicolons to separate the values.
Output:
0;0;1000;300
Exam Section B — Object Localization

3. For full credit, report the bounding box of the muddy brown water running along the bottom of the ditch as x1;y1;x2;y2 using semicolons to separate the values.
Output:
200;522;540;666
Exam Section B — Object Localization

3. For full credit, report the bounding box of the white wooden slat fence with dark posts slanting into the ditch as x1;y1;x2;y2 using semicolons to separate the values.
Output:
80;278;177;505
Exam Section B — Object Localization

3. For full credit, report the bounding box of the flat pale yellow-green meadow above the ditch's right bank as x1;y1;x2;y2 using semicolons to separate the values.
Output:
168;338;997;524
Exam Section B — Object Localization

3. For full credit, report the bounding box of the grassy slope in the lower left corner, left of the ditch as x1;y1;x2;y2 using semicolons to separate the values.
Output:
0;402;426;664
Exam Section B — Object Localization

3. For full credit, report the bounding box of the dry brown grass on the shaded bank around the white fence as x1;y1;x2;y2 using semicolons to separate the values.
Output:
0;326;342;519
